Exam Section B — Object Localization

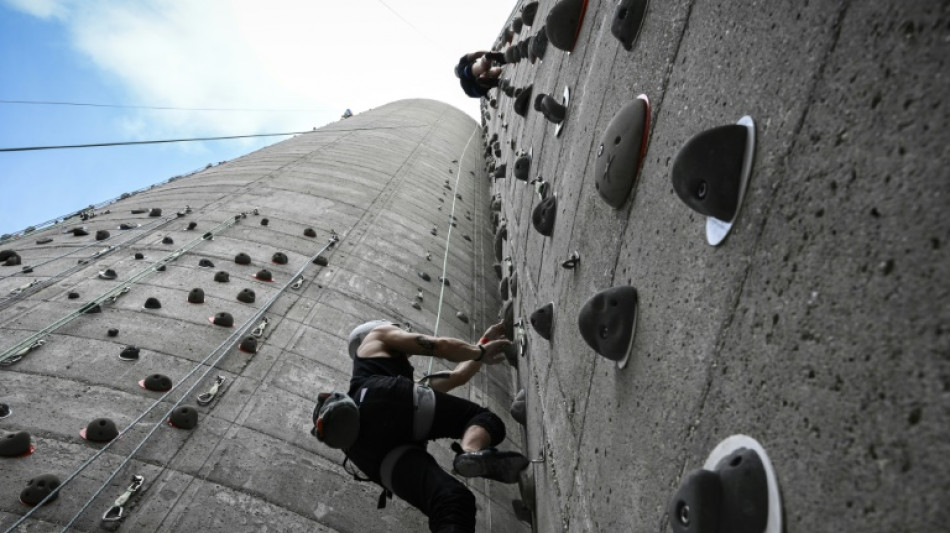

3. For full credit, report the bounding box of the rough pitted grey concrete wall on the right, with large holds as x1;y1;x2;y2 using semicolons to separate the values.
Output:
482;0;950;532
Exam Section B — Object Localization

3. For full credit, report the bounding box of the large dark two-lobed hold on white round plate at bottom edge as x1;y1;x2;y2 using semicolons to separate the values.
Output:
668;435;782;533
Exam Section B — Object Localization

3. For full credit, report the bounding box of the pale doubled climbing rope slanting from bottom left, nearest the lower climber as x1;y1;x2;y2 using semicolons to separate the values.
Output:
4;235;339;533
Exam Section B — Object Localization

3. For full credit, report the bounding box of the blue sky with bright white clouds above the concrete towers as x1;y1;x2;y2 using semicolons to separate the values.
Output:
0;0;513;233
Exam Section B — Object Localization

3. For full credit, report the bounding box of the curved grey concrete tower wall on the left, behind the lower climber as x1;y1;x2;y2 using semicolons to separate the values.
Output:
0;100;526;532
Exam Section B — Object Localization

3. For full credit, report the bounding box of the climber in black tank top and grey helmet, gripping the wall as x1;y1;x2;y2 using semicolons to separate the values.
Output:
311;320;529;533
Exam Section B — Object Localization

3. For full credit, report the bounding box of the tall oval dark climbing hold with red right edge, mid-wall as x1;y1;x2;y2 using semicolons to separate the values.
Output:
594;94;650;209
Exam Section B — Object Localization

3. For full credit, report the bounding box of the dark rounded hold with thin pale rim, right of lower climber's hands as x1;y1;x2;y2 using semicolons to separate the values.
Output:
577;285;638;368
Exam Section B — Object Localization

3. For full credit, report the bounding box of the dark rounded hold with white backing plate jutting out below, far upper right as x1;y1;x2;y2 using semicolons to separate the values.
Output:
670;115;755;246
